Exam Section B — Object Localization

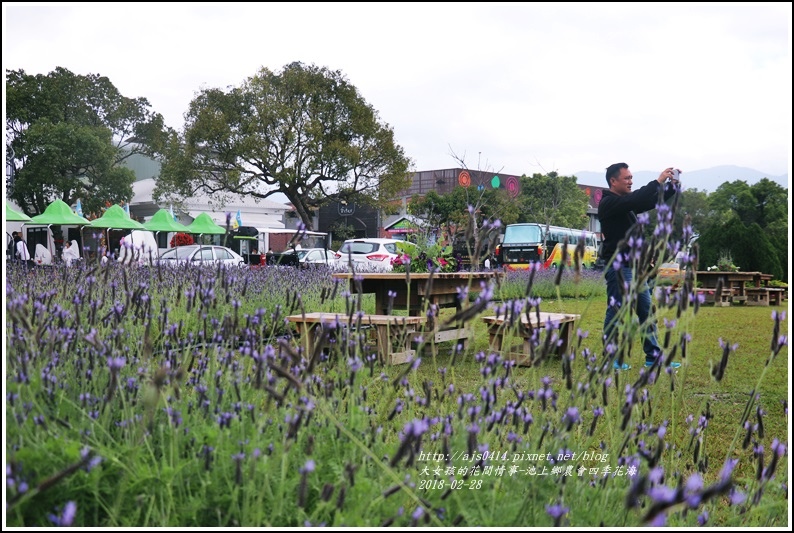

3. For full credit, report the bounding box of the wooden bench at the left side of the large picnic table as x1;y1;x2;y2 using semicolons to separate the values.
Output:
287;313;427;365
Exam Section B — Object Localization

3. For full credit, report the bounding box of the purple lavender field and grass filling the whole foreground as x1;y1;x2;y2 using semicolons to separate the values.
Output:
4;263;790;527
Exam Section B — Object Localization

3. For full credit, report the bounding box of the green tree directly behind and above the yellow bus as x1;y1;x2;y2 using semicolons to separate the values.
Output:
519;172;588;229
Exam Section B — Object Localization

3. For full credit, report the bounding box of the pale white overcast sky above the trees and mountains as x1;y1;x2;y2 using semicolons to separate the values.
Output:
3;2;792;179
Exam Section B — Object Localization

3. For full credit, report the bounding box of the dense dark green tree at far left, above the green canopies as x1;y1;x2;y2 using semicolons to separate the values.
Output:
6;67;164;215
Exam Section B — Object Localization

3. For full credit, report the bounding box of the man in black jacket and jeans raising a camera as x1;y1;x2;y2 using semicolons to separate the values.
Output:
598;163;681;370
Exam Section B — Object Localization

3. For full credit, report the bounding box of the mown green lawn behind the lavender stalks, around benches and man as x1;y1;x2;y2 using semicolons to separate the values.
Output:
324;286;789;524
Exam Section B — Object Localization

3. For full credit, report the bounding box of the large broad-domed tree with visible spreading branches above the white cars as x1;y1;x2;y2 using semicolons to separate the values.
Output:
154;62;411;229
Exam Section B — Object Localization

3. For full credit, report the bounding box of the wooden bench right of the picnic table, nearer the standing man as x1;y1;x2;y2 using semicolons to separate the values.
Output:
482;312;580;366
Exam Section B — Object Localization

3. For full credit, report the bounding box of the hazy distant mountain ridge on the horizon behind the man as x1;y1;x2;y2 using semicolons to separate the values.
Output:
574;165;789;193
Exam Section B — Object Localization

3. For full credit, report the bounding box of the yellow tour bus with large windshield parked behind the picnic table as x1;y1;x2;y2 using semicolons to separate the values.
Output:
496;223;601;270
